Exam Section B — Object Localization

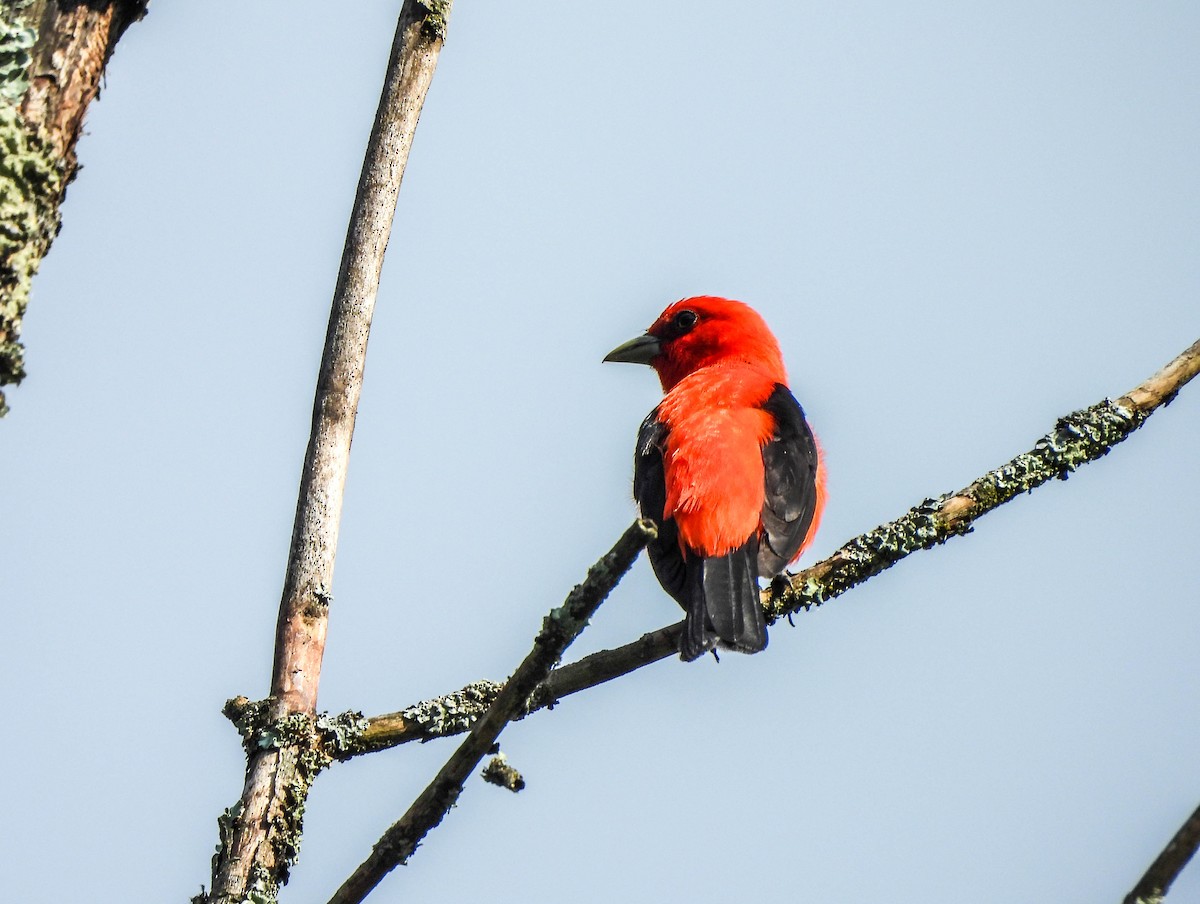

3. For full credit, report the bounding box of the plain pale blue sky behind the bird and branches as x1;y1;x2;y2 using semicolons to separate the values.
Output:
0;0;1200;904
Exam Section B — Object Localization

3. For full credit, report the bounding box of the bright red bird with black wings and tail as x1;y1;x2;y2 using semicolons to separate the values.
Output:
605;297;824;660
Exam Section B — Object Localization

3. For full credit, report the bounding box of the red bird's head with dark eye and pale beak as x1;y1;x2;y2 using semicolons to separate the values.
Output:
605;295;787;391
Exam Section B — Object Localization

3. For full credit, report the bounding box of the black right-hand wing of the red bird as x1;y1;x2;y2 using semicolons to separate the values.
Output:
758;383;818;577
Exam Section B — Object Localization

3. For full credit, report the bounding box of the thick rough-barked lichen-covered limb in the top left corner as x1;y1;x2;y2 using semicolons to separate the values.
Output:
0;0;146;417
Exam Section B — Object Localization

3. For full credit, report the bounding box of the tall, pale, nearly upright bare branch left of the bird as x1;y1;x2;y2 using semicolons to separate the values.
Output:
200;0;450;904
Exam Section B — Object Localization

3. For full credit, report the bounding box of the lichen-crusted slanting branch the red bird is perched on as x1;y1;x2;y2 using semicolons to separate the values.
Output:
337;341;1200;759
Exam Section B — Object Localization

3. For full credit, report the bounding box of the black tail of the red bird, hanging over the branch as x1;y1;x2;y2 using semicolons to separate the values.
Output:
679;537;767;661
